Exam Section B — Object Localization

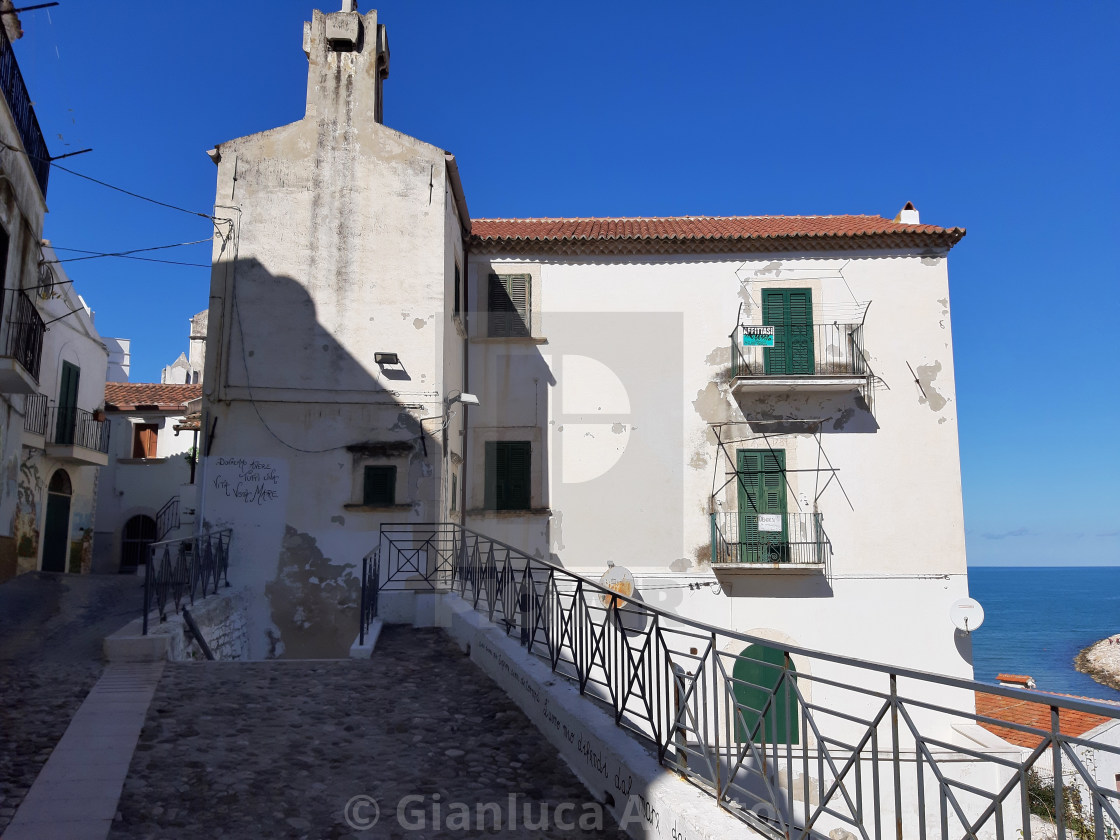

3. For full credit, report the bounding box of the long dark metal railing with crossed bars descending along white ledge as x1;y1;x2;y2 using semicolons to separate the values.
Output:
371;524;1120;840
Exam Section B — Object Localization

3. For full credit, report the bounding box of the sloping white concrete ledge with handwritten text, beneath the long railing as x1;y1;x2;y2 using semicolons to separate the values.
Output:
438;594;762;840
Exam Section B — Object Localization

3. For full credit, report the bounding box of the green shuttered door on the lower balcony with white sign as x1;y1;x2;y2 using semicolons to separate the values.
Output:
736;449;790;563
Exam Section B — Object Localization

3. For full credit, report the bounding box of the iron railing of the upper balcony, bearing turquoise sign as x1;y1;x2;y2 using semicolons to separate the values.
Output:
731;324;870;376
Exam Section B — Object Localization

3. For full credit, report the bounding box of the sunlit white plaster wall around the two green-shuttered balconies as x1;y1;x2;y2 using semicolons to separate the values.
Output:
469;245;971;689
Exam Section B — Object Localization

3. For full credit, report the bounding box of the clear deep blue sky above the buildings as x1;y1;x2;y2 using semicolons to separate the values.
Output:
6;0;1120;564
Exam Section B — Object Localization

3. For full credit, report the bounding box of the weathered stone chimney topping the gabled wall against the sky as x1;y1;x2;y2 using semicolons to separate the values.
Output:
304;0;389;127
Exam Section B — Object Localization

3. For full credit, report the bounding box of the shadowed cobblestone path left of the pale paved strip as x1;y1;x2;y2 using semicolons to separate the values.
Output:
0;572;142;833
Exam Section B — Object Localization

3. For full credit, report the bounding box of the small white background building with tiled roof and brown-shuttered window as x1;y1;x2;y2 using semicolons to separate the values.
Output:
93;382;202;573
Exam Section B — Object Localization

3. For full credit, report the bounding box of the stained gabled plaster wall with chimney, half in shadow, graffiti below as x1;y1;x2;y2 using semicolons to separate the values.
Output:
199;12;461;659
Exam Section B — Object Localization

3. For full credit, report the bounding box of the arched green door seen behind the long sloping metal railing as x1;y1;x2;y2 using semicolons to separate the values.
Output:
731;645;800;744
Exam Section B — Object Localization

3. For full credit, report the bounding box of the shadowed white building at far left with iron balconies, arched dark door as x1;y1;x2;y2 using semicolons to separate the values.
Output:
0;13;106;580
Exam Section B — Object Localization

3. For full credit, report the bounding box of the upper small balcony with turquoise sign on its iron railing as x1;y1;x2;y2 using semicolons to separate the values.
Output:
731;324;871;395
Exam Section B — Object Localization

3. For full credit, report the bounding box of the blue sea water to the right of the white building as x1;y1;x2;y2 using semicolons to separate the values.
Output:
969;567;1120;700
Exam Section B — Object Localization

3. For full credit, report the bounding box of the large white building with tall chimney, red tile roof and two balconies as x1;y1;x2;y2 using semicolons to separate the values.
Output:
200;1;971;676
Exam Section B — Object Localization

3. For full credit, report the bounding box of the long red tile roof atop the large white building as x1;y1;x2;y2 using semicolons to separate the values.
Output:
470;216;964;254
